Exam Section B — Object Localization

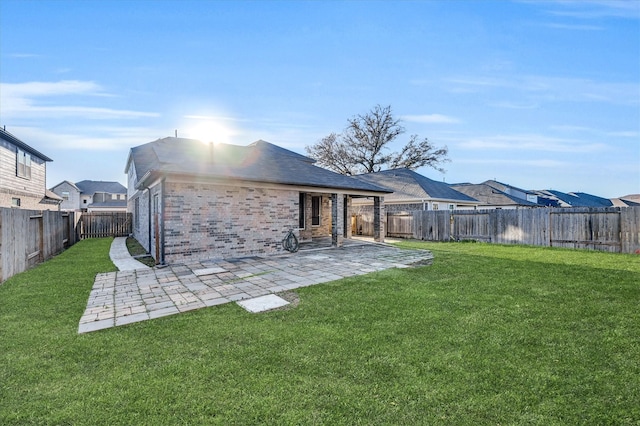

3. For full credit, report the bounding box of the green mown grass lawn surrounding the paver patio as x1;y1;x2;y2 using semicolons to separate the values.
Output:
0;239;640;425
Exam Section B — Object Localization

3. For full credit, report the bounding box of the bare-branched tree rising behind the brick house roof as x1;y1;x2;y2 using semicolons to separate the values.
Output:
305;105;449;175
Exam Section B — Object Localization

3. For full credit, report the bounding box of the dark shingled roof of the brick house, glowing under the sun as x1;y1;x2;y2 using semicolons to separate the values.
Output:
127;137;389;193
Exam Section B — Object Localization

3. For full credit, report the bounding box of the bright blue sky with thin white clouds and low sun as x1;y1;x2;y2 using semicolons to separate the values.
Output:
0;0;640;197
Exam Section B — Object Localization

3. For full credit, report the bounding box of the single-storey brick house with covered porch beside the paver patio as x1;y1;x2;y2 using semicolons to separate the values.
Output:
125;137;388;263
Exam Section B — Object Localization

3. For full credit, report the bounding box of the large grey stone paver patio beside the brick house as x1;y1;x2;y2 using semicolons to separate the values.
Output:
78;240;433;333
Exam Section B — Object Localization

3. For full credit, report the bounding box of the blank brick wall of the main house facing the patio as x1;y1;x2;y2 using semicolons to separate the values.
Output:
163;182;298;263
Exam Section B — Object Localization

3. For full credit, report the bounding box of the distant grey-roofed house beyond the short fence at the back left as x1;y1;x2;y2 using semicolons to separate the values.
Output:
51;180;127;212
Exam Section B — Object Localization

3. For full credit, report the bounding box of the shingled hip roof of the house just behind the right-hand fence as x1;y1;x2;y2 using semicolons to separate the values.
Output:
354;168;478;203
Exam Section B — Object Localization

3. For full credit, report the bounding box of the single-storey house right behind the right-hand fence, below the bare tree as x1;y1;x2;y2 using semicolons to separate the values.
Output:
353;168;479;213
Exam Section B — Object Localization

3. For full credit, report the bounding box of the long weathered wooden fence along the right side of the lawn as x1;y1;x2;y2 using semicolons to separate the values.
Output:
387;207;640;253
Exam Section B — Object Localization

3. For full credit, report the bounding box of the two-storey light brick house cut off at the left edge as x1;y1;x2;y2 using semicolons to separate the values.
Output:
0;128;62;210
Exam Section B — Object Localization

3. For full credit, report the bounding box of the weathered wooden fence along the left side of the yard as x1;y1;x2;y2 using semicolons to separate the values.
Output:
0;208;76;282
